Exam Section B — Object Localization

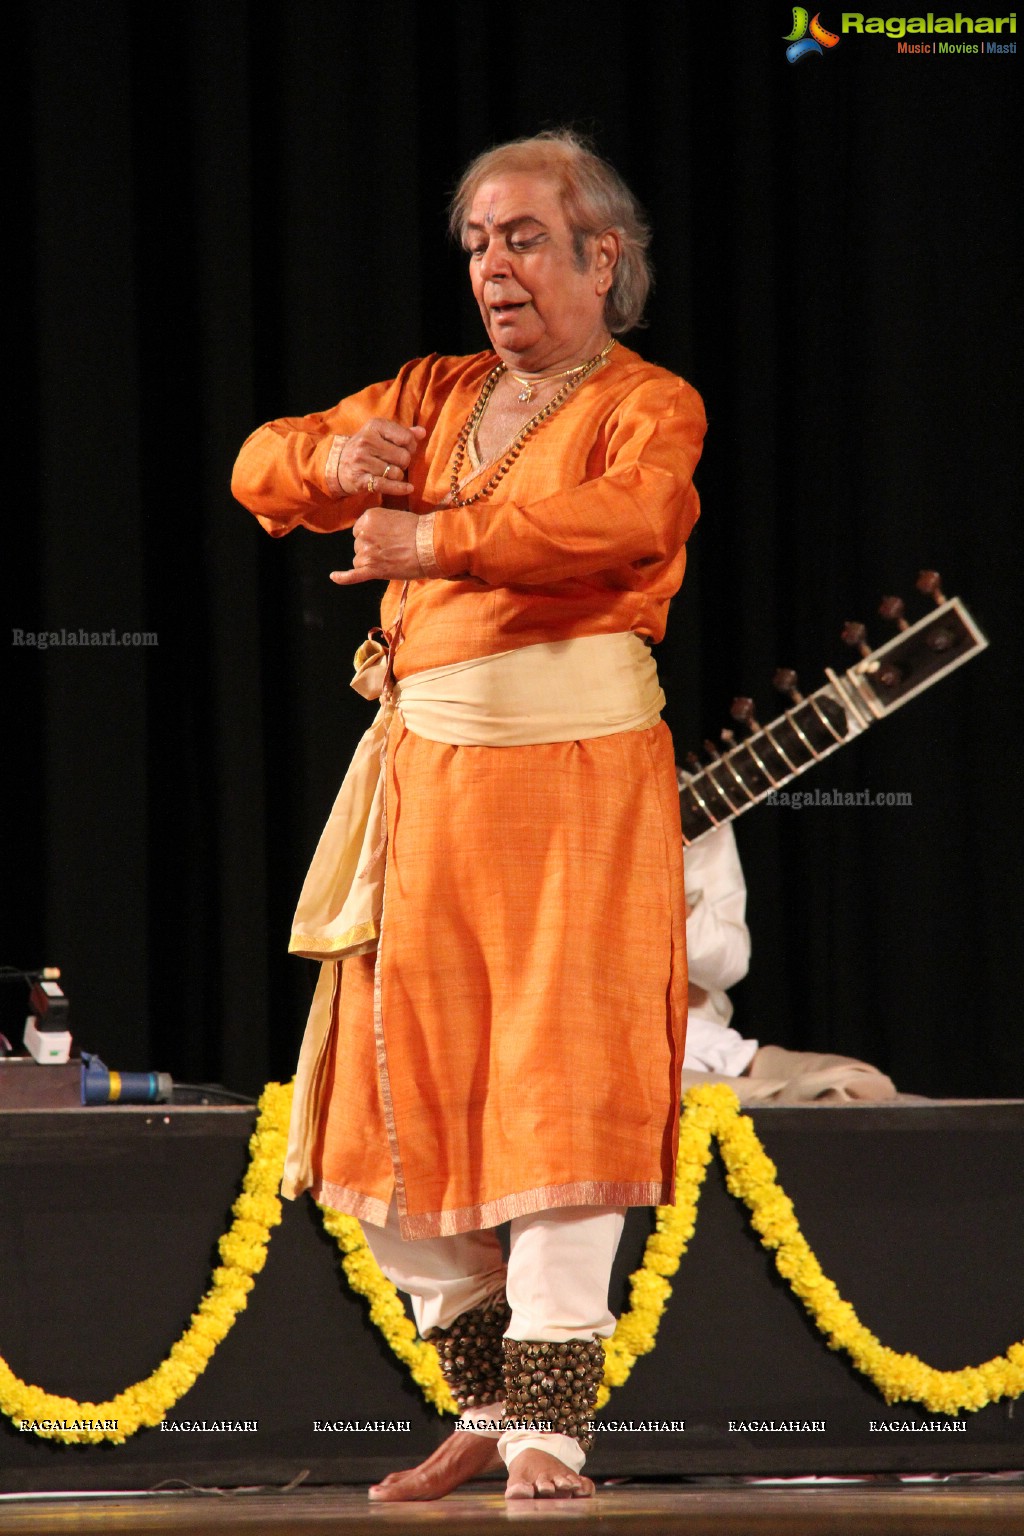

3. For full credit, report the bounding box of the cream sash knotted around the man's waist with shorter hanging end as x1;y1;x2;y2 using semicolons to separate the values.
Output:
289;634;665;960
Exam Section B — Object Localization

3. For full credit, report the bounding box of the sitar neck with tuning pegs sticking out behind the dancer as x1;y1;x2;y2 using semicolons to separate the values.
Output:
677;571;989;846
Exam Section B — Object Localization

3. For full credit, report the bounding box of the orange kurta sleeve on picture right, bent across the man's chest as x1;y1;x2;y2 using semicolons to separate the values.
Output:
433;375;706;587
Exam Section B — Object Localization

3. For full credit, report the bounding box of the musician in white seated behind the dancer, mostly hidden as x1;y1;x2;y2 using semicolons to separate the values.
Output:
683;825;898;1104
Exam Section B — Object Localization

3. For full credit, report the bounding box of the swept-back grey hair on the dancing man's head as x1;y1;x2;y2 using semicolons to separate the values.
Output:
448;127;654;335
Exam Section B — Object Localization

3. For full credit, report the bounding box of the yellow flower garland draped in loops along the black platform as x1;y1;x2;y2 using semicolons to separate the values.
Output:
0;1083;1024;1444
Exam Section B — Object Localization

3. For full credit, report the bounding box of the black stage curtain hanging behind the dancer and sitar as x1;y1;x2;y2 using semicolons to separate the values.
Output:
0;0;1024;1095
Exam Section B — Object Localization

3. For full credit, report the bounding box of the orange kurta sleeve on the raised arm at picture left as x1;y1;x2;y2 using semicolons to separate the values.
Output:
232;358;433;538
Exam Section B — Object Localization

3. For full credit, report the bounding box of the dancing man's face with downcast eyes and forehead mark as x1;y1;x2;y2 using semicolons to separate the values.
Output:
465;172;609;372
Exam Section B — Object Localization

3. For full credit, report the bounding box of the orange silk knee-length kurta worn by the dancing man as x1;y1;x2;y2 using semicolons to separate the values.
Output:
232;346;705;1238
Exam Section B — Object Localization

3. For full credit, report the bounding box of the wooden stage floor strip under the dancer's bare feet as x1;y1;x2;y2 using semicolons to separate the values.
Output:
0;1475;1024;1536
